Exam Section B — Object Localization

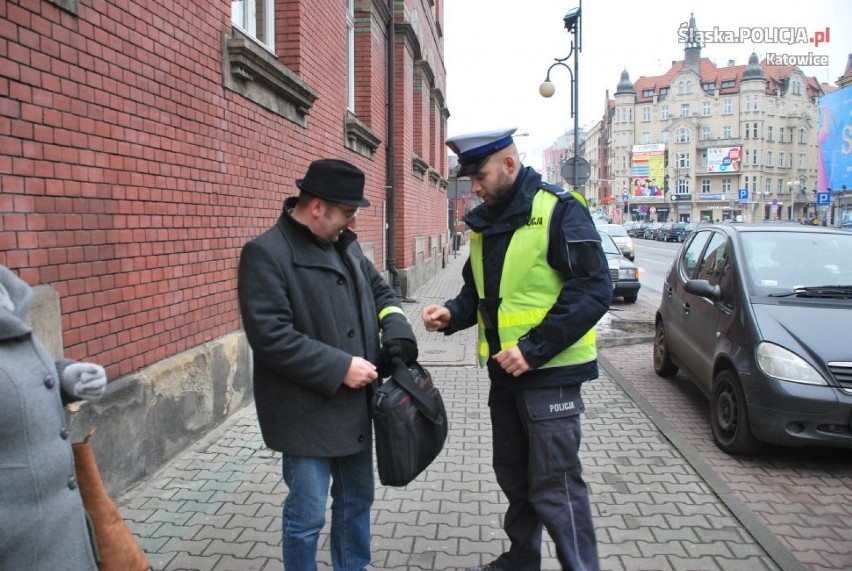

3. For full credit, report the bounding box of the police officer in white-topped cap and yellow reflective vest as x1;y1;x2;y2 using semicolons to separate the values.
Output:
421;129;612;571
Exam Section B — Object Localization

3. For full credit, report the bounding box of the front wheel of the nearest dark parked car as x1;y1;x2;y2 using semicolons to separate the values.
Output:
710;370;761;454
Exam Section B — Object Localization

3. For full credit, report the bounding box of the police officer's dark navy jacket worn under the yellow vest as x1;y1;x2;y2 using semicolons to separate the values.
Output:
444;167;612;390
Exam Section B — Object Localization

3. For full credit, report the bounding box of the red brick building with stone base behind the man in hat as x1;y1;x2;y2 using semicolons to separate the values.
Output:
0;0;449;489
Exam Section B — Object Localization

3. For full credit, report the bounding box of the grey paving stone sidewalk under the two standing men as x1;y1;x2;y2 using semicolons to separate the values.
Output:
117;247;795;571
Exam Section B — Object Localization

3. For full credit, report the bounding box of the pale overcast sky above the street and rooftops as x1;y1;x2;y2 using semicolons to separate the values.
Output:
444;0;852;168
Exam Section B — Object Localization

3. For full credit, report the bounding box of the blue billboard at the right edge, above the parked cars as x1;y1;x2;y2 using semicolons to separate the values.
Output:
816;85;852;192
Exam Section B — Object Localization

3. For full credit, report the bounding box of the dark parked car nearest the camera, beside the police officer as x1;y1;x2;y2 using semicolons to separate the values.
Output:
654;224;852;454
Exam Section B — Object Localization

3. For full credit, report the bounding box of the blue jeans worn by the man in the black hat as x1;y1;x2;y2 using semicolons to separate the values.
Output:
282;449;375;571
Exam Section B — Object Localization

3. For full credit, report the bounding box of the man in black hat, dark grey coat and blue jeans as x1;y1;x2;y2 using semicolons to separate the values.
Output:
238;159;417;571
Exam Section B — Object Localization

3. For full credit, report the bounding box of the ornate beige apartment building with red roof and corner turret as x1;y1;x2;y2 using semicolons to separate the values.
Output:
598;14;833;225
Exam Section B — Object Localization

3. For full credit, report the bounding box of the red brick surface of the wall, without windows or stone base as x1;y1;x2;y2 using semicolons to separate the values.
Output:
0;0;447;379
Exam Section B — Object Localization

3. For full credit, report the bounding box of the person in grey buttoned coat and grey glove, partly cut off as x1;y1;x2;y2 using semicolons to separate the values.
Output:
0;266;107;571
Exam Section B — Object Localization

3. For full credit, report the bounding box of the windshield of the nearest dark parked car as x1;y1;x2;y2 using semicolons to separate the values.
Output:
741;232;852;294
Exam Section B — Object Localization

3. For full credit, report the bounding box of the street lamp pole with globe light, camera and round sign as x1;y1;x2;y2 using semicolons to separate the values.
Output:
538;0;592;191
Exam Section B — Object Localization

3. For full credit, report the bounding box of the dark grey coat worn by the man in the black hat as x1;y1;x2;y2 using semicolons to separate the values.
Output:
238;197;415;457
